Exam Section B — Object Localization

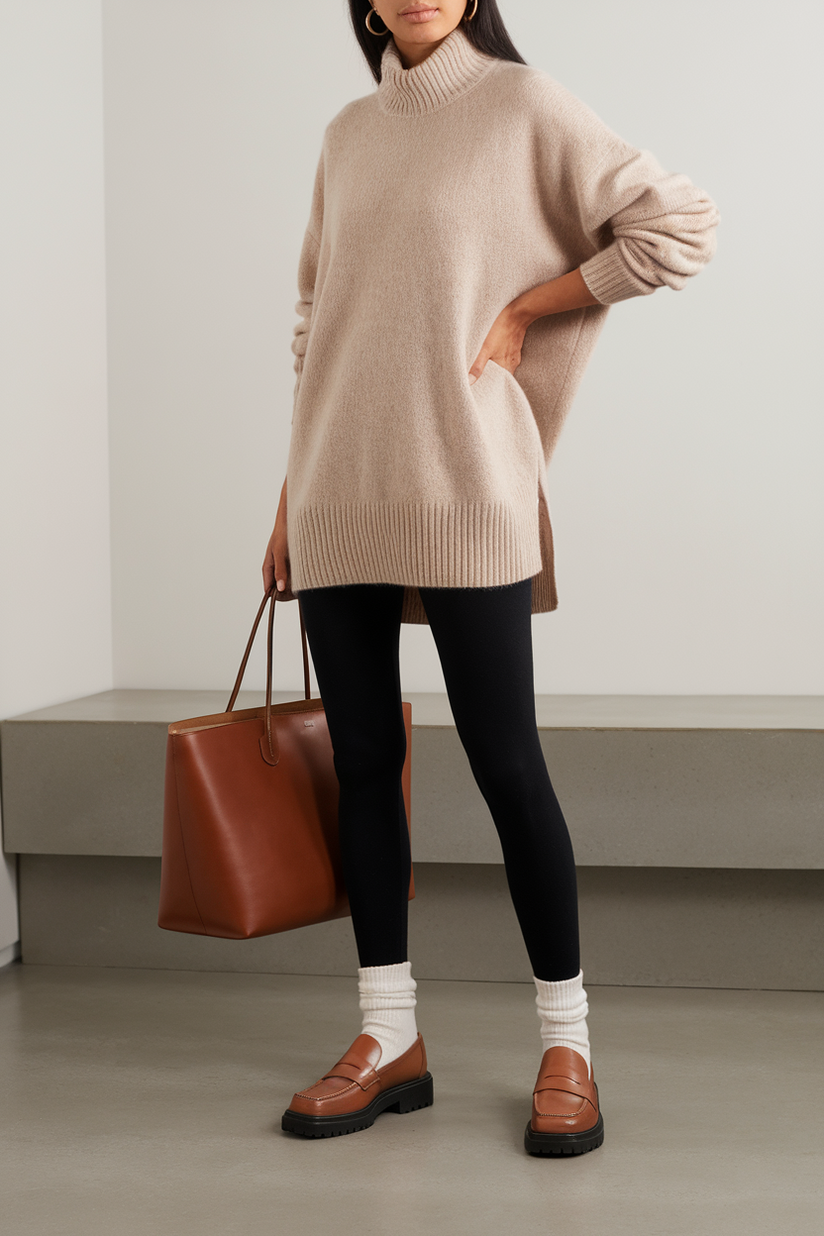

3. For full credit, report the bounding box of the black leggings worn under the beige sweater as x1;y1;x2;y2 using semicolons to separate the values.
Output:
300;580;579;981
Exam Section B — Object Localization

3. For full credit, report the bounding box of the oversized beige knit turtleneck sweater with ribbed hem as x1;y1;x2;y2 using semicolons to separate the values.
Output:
287;26;719;622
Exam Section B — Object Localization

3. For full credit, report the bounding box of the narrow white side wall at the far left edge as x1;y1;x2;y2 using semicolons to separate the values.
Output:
0;0;111;955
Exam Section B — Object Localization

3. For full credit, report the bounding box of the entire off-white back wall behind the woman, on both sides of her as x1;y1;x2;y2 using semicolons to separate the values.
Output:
98;0;824;693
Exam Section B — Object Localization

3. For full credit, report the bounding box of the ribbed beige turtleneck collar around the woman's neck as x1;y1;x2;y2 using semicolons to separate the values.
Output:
378;26;498;116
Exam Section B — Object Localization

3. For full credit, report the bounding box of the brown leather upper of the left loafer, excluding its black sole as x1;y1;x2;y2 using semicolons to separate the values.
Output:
289;1035;426;1116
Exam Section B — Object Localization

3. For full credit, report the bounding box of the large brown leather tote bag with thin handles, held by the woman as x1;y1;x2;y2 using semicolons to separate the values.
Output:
158;590;415;939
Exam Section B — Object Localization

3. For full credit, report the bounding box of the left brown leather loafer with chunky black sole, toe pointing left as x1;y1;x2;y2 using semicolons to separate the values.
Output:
280;1035;432;1137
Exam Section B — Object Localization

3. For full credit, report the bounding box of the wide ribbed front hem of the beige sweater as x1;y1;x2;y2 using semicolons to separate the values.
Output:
289;494;541;592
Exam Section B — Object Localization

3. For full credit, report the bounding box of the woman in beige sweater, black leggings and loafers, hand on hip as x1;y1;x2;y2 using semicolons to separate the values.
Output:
263;0;719;1154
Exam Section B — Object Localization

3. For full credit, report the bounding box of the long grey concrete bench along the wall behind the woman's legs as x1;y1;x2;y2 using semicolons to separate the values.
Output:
1;690;824;989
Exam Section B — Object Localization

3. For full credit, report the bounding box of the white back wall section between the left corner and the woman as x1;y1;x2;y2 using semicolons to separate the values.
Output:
104;0;368;687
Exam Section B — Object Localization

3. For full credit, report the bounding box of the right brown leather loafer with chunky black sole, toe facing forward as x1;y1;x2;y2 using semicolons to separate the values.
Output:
524;1047;604;1154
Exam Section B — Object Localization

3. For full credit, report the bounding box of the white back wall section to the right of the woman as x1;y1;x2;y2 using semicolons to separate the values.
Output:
521;0;824;695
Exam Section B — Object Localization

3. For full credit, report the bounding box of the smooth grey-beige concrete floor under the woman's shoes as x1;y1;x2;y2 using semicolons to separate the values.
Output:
0;965;824;1236
